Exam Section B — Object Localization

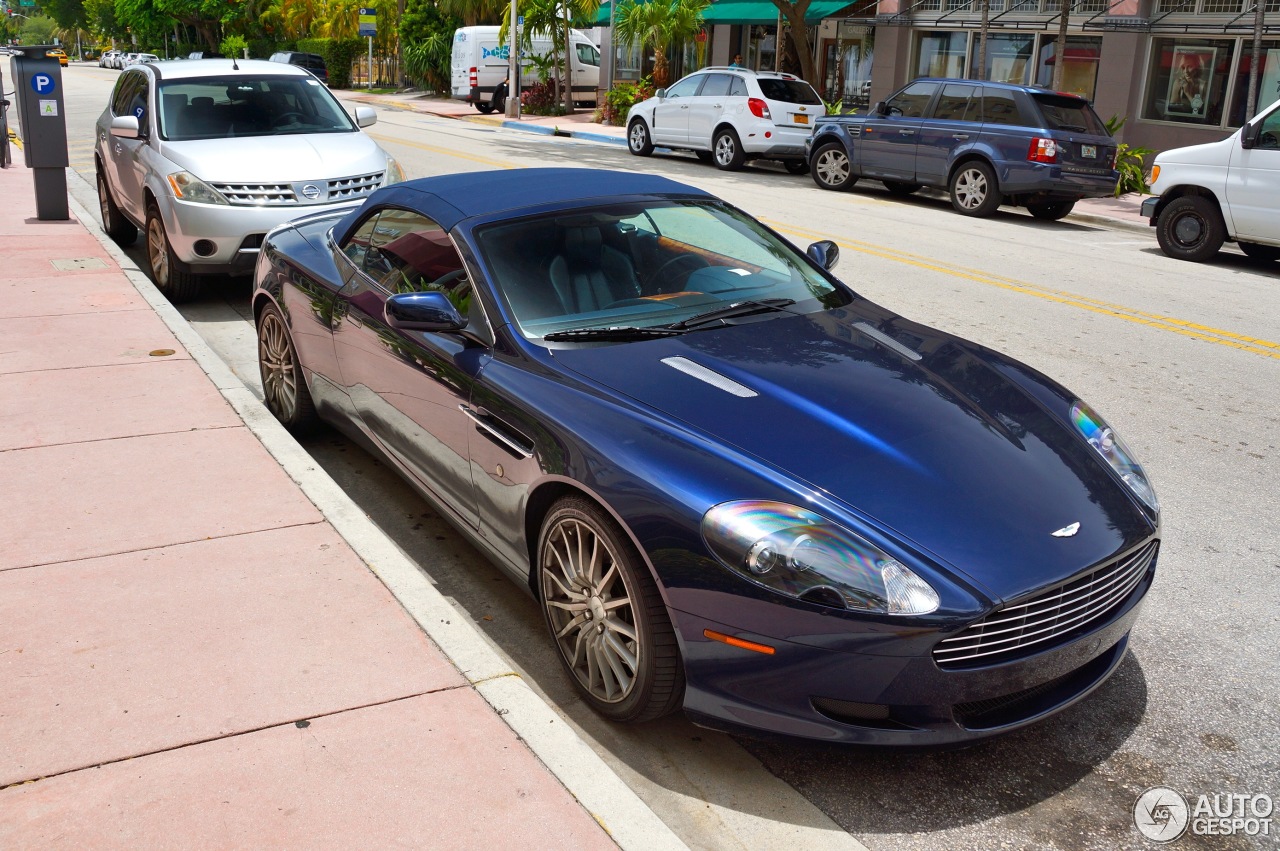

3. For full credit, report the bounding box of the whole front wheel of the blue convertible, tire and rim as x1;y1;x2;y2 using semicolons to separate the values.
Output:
535;497;685;722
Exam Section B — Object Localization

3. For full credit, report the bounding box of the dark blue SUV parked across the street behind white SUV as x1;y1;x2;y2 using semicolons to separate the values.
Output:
809;79;1120;220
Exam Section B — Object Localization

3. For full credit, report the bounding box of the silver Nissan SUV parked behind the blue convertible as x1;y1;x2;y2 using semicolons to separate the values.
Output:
93;59;404;301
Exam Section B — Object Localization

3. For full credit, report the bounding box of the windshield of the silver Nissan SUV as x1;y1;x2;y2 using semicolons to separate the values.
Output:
160;74;356;142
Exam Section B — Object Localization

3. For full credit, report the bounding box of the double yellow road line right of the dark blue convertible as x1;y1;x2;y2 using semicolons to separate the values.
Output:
764;220;1280;360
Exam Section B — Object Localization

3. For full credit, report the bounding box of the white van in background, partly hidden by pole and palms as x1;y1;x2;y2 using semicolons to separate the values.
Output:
449;27;600;113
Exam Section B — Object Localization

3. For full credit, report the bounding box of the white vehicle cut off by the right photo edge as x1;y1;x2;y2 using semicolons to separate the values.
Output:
1142;101;1280;262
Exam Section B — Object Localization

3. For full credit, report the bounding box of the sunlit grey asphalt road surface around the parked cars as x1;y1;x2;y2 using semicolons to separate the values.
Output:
55;65;1280;851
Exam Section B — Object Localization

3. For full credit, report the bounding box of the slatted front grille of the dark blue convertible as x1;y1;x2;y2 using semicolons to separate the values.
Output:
933;541;1160;671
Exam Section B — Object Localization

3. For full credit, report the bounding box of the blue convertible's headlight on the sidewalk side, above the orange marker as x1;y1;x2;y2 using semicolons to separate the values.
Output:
703;500;940;614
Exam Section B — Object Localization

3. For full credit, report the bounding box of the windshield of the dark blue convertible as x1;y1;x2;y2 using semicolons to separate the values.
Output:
477;201;852;340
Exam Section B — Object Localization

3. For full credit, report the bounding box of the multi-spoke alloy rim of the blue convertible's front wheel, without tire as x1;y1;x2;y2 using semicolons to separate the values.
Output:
540;516;645;704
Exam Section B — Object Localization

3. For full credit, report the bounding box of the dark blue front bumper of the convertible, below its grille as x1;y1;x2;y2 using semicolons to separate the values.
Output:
673;555;1155;747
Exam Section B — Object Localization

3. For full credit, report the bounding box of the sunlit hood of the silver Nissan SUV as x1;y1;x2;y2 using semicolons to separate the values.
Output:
161;133;387;183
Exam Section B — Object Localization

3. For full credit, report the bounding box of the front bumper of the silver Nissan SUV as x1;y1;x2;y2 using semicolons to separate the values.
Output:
160;196;367;274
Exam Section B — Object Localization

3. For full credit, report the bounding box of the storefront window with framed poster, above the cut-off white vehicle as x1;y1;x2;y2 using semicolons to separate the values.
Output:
1142;38;1236;127
